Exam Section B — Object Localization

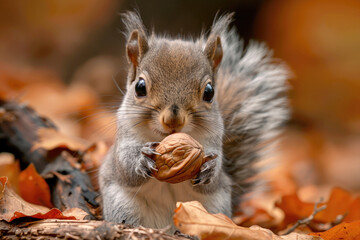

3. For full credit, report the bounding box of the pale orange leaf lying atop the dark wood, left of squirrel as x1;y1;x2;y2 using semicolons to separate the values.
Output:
32;128;89;151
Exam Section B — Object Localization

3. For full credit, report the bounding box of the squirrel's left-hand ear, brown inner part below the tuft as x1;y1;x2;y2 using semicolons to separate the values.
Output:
126;30;149;68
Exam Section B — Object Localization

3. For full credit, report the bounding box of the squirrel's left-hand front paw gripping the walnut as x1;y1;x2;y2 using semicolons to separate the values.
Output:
135;142;159;178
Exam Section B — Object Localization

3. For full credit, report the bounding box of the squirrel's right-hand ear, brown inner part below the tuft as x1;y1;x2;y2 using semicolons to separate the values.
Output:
204;35;223;70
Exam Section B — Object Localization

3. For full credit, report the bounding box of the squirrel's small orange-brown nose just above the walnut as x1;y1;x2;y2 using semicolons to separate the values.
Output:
161;105;185;132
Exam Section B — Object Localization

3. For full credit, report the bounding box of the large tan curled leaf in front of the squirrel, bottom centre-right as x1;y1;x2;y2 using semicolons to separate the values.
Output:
173;201;321;240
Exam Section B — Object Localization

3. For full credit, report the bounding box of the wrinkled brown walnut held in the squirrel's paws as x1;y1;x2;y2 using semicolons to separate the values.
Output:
152;133;213;183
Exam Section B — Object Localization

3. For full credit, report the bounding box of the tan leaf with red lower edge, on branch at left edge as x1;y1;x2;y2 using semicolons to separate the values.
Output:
0;177;76;222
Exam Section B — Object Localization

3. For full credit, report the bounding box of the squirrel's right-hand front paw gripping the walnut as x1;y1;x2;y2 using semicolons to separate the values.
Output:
191;153;217;186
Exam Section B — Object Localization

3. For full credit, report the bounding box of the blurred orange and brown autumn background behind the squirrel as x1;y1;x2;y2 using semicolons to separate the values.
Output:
0;0;360;200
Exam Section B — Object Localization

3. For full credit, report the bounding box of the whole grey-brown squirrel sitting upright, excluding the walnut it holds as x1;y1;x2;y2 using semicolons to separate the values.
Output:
99;12;288;229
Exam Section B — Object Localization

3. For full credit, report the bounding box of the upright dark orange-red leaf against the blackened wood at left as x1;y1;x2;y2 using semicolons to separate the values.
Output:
19;163;53;208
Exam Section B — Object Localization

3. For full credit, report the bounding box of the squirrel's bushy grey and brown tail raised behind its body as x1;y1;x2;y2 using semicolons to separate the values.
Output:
215;20;289;210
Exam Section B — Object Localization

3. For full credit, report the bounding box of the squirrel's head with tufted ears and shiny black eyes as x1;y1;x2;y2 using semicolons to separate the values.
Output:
119;12;231;141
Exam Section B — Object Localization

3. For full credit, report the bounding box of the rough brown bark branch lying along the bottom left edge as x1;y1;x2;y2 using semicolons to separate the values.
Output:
0;219;191;240
